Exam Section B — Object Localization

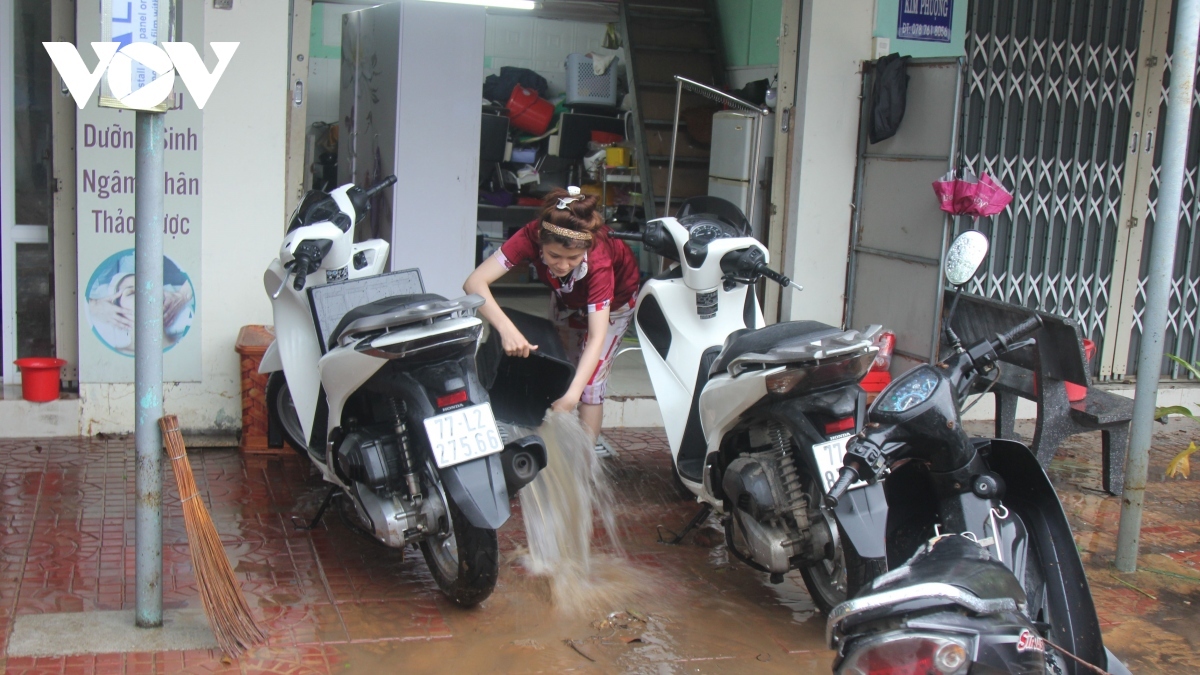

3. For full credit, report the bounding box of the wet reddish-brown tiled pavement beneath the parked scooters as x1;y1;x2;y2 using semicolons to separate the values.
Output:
0;422;1200;674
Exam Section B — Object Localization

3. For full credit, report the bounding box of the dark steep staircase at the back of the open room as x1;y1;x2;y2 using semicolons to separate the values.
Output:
620;0;727;220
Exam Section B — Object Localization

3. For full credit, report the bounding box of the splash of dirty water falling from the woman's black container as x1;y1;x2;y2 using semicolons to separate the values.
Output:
520;412;640;613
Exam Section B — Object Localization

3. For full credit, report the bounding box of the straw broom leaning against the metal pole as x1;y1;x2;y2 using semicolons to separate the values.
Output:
158;414;266;657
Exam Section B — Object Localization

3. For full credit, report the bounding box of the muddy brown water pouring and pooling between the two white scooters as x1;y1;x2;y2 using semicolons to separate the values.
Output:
352;419;832;674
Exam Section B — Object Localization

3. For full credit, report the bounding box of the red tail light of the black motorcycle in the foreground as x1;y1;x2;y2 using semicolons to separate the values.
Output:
838;632;971;675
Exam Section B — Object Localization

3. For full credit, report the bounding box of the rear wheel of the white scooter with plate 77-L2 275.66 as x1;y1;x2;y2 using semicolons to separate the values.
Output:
421;487;500;607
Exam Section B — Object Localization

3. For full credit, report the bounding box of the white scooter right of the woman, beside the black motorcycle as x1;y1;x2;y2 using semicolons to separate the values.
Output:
612;197;887;613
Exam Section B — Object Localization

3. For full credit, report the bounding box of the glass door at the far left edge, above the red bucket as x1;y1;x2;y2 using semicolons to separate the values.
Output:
0;0;55;383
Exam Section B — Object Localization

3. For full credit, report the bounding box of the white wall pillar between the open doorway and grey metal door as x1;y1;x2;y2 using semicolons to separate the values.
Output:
781;0;875;325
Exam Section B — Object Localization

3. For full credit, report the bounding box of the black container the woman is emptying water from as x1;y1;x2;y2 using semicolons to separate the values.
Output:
475;309;575;426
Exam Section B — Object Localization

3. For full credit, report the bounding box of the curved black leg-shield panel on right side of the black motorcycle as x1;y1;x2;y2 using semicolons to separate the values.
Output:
986;438;1108;667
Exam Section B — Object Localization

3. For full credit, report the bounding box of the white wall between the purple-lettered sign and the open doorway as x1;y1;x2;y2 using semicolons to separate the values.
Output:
79;0;290;435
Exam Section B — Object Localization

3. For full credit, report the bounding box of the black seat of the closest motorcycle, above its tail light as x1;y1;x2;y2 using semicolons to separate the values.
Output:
859;534;1026;605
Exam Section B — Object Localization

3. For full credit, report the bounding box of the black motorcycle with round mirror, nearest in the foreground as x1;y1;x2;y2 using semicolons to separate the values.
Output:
827;232;1128;675
